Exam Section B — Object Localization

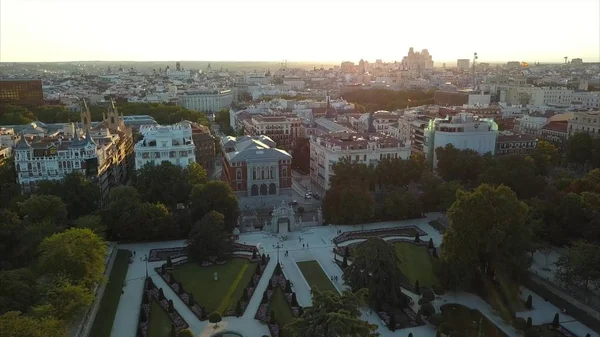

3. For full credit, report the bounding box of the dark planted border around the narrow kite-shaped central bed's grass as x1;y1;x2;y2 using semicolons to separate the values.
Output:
254;265;303;337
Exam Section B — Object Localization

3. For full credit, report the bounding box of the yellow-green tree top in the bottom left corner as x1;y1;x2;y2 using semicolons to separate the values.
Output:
0;311;67;337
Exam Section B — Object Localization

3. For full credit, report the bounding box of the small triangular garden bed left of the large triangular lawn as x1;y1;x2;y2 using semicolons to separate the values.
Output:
137;277;188;337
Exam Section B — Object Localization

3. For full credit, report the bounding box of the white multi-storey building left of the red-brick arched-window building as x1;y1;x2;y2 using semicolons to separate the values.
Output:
134;123;196;170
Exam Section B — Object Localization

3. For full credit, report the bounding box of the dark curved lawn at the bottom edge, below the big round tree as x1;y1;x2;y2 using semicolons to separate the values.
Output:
440;304;508;337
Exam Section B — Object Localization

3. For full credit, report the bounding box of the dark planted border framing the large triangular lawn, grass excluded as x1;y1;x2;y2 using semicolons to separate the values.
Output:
155;254;270;321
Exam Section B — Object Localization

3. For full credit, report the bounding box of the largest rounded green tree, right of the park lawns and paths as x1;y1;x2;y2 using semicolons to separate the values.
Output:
441;184;532;288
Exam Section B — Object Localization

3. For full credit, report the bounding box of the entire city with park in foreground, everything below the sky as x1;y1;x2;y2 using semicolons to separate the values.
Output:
0;0;600;337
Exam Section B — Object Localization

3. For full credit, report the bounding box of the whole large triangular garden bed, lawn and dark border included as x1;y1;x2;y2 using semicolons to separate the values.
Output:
156;255;269;321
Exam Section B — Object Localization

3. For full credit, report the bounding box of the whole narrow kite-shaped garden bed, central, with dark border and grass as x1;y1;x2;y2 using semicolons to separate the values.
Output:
254;264;304;337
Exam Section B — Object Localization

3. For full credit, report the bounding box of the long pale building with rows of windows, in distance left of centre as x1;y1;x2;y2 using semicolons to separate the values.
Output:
178;89;233;112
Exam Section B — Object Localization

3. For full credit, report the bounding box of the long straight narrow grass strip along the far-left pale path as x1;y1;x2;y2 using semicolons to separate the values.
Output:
90;249;131;337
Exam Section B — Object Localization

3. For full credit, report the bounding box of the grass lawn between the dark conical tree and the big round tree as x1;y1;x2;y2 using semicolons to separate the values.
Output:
394;242;438;287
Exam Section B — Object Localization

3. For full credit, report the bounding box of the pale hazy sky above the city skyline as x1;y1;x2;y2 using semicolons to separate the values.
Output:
0;0;600;65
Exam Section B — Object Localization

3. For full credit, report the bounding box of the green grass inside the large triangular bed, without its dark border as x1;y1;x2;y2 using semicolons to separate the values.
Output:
173;259;258;313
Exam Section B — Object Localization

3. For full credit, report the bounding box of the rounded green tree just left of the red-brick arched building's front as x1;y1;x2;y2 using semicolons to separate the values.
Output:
190;181;240;231
